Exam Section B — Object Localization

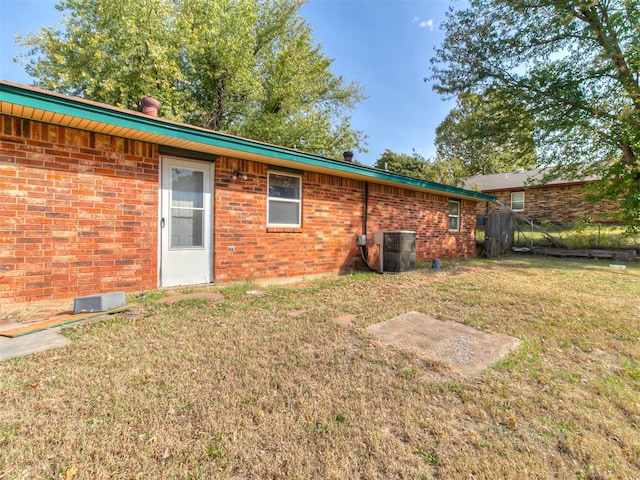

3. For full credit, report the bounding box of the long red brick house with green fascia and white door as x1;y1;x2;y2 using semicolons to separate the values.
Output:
0;82;492;310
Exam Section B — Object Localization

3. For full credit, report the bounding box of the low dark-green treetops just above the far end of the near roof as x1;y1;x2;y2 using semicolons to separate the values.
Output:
373;148;464;186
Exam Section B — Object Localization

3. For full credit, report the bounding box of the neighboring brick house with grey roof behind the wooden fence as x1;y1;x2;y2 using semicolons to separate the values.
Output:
464;169;620;225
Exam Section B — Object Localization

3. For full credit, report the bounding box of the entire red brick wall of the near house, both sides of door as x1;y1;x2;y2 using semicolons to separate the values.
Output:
0;113;475;309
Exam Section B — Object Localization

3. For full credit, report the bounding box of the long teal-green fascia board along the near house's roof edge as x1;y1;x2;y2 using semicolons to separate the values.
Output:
0;82;495;201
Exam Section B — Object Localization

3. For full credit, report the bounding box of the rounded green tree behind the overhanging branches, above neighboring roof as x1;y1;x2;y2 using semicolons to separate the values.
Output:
435;90;536;176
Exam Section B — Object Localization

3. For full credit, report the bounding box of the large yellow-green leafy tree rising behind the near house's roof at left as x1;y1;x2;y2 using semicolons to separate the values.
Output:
19;0;366;158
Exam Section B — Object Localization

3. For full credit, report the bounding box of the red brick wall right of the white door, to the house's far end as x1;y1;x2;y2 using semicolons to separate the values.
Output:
214;158;475;282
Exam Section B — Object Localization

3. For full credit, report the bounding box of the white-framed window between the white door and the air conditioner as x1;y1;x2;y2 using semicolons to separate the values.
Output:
267;172;302;227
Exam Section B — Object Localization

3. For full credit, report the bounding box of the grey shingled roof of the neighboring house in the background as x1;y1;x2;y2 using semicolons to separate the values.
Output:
464;168;597;192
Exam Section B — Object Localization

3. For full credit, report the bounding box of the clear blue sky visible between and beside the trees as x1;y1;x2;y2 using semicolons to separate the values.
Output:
0;0;462;165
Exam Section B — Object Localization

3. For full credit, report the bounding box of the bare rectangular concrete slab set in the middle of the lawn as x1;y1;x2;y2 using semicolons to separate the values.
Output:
367;312;520;378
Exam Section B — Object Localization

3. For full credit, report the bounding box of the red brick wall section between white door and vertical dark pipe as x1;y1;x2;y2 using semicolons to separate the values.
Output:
214;158;364;282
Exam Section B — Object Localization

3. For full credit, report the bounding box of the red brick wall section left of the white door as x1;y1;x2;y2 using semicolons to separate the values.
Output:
0;117;158;306
